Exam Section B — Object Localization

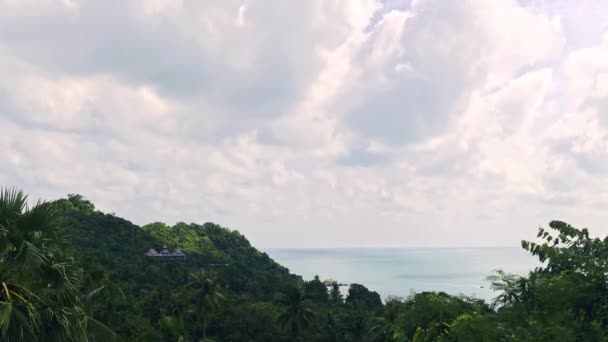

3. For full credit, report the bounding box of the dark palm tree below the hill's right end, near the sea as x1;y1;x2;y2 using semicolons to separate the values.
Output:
277;287;315;340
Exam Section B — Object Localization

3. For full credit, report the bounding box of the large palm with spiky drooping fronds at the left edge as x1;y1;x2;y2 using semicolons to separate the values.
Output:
0;189;87;341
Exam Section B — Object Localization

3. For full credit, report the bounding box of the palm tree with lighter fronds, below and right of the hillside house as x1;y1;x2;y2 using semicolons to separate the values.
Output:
187;271;224;341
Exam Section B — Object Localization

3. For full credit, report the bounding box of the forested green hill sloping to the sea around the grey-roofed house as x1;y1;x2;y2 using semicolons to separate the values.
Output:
54;195;302;336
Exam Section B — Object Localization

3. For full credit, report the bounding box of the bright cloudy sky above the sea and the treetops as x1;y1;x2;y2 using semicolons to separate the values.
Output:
0;0;608;247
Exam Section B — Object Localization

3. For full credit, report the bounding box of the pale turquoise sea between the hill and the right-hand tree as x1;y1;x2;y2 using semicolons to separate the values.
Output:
266;247;539;301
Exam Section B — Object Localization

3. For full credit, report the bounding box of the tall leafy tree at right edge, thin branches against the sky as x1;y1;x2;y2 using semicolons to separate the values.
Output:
521;221;608;340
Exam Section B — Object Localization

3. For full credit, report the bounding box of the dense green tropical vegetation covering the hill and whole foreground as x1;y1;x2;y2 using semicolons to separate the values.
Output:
0;190;608;342
